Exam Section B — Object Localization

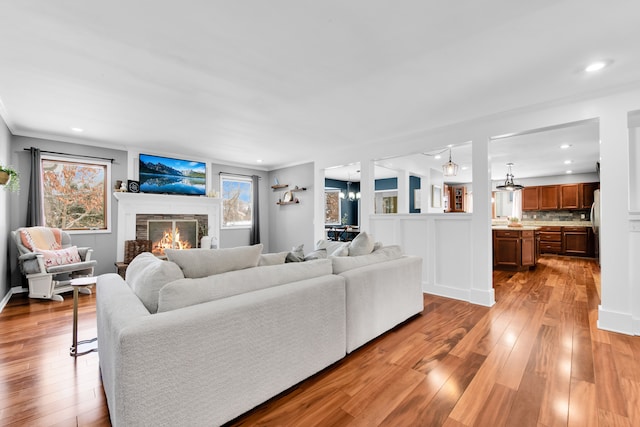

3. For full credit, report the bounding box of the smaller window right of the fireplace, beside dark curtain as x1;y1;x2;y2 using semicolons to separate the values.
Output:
220;176;253;228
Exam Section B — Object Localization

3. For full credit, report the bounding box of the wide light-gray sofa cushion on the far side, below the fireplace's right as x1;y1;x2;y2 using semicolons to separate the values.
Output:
164;244;262;279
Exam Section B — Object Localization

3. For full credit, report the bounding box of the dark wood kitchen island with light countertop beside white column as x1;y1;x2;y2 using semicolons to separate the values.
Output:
492;225;539;271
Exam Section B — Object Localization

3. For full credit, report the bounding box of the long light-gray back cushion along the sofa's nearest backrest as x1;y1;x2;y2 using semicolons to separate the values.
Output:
158;259;332;312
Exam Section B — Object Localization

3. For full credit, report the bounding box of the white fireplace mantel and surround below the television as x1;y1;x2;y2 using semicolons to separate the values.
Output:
113;192;221;261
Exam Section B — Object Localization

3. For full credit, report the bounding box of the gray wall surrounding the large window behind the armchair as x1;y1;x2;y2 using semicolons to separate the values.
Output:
10;136;127;286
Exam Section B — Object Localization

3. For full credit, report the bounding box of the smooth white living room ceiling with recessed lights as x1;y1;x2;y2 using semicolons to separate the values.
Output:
0;0;640;171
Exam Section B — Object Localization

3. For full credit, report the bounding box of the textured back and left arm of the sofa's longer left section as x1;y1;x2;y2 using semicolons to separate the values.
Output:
97;273;346;425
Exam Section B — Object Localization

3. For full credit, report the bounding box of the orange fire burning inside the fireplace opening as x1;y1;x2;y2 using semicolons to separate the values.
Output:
147;220;198;256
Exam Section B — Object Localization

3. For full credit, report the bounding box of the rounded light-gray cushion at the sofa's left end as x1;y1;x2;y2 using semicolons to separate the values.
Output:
125;252;184;313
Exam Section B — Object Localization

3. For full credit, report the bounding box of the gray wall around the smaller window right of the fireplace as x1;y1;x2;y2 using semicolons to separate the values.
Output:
211;163;271;253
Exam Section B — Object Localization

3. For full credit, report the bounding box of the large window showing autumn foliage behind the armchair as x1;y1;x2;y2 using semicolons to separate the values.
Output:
42;156;111;232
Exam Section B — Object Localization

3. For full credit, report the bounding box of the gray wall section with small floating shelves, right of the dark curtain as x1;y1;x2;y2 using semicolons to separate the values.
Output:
269;163;314;254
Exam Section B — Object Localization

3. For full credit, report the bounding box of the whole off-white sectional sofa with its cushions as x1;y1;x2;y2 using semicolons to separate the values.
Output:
97;237;423;426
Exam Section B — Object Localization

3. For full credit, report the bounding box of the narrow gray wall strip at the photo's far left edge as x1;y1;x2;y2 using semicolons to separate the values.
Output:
0;113;10;301
